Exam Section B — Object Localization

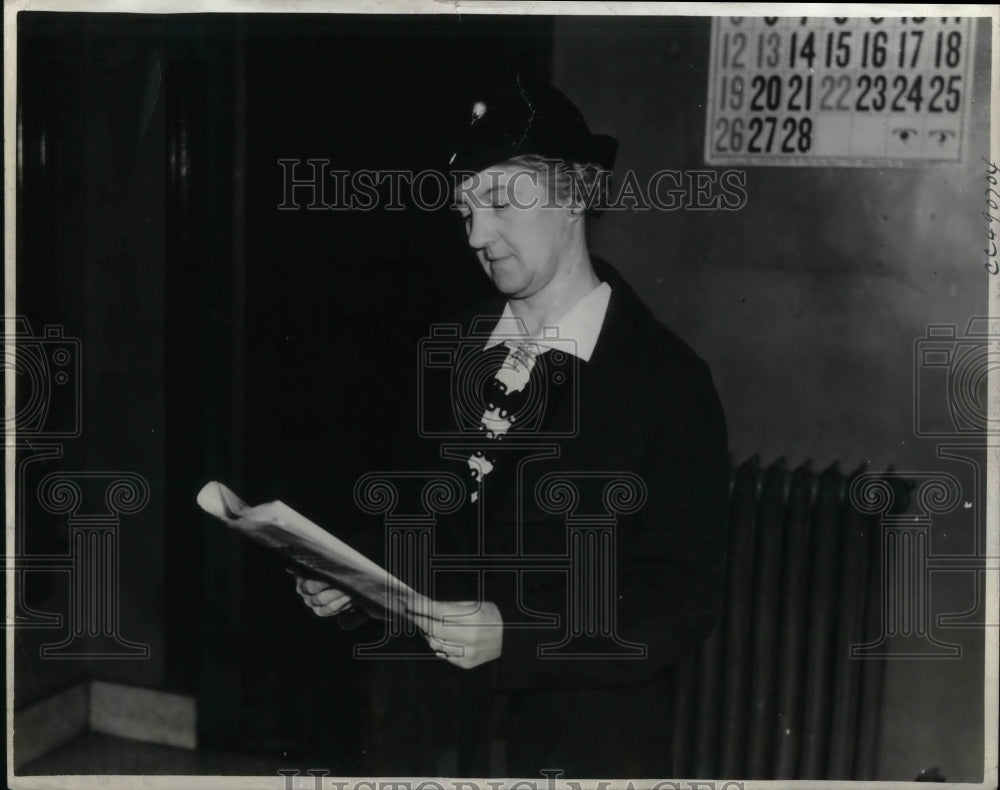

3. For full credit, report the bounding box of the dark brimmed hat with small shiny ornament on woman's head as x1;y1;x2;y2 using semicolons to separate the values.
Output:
448;85;618;172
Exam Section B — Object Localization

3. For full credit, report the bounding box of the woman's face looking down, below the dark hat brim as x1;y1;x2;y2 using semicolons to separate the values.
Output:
457;166;578;299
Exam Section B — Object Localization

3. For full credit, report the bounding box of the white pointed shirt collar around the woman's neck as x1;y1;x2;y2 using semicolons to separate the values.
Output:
484;282;611;362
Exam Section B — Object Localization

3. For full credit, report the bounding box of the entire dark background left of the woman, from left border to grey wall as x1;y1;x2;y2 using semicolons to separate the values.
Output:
18;9;552;774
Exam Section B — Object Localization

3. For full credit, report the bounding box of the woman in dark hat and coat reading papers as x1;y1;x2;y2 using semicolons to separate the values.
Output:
298;86;728;778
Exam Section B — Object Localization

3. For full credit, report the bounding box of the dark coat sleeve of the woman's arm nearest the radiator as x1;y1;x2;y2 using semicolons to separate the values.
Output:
493;355;729;689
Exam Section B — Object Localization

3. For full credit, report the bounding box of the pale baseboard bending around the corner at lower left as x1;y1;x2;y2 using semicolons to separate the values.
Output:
14;680;198;770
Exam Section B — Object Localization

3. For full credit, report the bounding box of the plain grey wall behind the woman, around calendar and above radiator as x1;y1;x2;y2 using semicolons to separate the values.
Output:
553;12;989;780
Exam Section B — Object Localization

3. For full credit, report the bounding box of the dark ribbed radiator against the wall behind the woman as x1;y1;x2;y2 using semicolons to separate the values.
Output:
668;458;906;780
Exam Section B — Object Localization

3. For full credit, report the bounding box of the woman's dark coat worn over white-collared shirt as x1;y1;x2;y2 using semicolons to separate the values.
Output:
352;261;729;778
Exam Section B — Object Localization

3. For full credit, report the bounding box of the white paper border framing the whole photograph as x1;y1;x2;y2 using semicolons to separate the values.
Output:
3;0;1000;790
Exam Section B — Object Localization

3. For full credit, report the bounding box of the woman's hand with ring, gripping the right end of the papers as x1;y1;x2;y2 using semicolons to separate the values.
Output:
408;601;503;669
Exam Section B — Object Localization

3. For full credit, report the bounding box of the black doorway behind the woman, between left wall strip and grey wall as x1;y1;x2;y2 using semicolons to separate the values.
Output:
168;15;551;774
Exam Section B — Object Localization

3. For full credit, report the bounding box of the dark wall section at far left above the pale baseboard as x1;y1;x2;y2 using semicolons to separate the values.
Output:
15;20;165;707
